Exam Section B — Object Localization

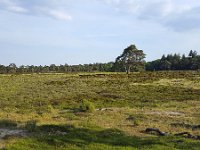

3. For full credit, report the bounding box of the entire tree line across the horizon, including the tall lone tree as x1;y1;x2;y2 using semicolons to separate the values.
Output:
0;45;200;74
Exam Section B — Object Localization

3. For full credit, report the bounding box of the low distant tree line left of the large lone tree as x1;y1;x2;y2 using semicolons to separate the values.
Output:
0;62;113;74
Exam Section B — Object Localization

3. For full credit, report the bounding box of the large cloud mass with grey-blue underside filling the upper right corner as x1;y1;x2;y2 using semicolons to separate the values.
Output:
99;0;200;32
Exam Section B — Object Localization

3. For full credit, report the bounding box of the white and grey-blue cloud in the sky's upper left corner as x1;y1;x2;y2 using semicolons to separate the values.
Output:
0;0;72;21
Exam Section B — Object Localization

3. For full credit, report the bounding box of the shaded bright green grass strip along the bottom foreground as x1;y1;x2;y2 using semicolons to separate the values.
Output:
7;125;200;150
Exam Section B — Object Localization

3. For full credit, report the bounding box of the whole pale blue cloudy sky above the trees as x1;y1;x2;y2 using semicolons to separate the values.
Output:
0;0;200;65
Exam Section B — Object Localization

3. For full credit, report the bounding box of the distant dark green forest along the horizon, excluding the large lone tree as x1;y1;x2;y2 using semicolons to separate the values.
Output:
0;50;200;74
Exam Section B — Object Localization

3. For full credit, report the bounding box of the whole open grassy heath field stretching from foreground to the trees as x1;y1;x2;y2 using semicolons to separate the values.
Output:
0;71;200;150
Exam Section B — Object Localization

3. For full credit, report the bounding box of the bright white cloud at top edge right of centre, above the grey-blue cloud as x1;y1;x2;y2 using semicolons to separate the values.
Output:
99;0;192;18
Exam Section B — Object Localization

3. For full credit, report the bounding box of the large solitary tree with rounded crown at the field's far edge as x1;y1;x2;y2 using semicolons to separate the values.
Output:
116;45;145;74
